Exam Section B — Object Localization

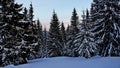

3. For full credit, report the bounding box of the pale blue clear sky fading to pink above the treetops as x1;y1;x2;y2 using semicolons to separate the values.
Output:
16;0;92;27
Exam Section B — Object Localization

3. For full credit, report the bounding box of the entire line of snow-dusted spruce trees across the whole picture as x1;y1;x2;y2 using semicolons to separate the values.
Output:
0;0;120;66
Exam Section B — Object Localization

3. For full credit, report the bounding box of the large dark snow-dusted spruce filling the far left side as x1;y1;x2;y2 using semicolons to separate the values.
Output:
1;0;30;65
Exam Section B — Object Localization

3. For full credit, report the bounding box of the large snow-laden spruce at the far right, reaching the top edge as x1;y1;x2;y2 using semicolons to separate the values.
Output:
91;0;120;56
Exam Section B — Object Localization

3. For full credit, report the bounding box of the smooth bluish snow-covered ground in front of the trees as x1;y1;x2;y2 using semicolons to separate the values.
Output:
5;57;120;68
